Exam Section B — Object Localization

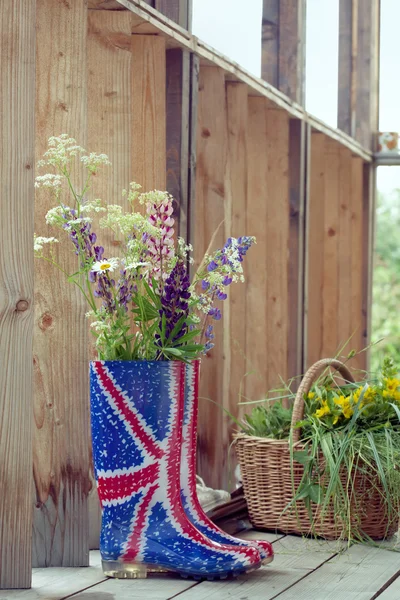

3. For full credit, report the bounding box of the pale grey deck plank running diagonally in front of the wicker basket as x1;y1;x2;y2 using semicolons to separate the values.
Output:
276;545;399;600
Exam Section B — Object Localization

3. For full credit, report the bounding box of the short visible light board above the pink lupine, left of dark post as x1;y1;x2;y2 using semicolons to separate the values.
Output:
131;35;166;192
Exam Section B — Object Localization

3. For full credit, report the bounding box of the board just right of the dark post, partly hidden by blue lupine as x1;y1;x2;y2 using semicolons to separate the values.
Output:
193;67;227;487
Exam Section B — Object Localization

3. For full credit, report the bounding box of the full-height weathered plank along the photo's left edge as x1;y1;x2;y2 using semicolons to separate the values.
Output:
0;0;36;588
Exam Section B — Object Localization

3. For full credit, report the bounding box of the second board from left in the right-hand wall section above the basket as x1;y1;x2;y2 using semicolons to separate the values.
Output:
322;138;340;357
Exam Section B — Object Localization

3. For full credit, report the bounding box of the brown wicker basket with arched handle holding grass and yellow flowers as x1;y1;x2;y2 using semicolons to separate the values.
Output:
236;359;398;540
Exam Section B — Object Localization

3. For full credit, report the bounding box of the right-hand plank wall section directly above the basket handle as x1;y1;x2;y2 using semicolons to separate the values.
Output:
305;132;370;369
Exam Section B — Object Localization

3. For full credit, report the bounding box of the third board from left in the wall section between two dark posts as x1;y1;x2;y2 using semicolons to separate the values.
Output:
244;97;270;400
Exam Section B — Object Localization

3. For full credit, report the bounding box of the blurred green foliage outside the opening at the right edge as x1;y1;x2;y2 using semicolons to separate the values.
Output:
371;189;400;372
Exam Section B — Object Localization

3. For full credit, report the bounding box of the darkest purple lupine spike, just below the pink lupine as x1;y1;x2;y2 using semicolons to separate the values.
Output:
156;260;190;343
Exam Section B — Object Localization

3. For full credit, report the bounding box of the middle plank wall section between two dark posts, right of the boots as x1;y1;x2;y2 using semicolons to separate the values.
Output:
193;67;297;487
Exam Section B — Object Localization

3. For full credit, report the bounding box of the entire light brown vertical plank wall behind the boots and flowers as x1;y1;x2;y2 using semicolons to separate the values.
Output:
0;0;372;587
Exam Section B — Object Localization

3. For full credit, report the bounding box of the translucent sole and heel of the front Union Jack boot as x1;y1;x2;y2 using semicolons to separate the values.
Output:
102;559;260;581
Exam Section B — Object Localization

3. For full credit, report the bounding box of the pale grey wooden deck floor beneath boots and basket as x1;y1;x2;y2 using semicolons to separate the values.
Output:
0;531;400;600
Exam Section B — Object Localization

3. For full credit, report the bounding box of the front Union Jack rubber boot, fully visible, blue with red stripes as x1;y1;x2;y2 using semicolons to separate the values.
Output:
90;361;261;579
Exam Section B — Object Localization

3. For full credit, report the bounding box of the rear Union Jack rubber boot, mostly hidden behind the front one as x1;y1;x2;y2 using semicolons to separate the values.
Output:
181;360;274;565
